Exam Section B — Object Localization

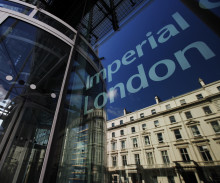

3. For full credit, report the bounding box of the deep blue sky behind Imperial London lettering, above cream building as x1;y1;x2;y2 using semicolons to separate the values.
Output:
99;0;220;120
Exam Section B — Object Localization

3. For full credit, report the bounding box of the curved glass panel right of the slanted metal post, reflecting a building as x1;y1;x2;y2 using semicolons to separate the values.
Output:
45;52;106;183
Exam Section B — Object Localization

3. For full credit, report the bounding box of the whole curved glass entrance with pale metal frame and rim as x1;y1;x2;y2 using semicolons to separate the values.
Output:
0;0;106;183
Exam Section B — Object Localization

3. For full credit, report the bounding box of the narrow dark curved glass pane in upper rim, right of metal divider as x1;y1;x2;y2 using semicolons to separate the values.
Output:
34;11;75;39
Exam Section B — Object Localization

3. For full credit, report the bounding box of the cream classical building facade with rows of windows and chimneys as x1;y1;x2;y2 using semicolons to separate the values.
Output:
107;79;220;183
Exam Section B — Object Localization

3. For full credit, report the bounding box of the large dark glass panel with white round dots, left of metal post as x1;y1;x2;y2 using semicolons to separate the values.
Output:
0;18;70;182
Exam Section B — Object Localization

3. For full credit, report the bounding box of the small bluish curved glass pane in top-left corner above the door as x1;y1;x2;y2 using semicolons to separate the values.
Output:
0;0;33;15
